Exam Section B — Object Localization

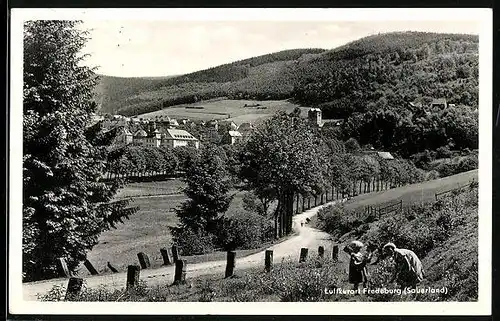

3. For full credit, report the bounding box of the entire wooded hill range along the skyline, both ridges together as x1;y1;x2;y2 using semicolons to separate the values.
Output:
95;32;479;118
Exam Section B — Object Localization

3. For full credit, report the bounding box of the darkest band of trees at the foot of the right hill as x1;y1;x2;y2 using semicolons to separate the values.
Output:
342;106;479;157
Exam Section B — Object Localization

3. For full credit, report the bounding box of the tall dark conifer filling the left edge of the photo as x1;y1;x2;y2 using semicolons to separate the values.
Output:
23;20;136;281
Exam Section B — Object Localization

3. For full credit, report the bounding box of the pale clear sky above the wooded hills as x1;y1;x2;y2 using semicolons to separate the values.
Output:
82;20;479;77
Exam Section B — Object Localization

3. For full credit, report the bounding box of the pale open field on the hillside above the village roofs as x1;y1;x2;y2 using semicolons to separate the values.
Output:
138;99;308;124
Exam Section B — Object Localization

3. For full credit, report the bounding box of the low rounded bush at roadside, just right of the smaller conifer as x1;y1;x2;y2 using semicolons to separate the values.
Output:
217;212;274;250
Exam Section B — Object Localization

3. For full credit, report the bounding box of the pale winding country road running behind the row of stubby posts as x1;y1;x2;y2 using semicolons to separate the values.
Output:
23;202;344;300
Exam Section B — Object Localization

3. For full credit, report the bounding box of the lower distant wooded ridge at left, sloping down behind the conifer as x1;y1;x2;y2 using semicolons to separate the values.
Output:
96;49;326;115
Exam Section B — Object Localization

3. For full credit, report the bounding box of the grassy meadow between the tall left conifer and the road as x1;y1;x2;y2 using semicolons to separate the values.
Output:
84;186;252;276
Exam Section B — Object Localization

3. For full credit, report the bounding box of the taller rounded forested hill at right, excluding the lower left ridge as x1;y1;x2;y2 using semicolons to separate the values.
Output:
293;32;479;118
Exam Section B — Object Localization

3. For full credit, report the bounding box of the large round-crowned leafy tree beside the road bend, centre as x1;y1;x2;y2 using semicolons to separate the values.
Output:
240;113;328;237
